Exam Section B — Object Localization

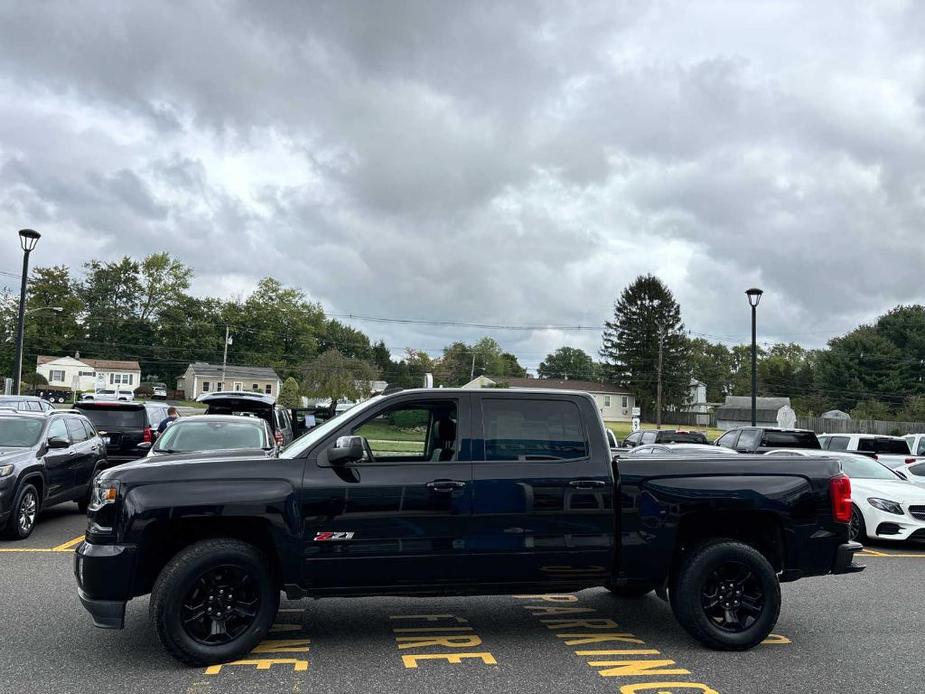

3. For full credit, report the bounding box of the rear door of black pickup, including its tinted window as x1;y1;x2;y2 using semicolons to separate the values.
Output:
469;397;615;583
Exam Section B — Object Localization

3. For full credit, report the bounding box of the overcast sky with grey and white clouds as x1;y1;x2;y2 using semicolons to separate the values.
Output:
0;0;925;366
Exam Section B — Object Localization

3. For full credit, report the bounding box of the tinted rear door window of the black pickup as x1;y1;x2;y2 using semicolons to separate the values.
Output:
482;398;587;462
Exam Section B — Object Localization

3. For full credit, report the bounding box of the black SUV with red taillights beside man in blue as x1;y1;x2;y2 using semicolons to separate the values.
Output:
74;400;167;463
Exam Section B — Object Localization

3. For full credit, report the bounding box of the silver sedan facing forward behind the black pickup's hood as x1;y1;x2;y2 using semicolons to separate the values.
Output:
148;415;278;458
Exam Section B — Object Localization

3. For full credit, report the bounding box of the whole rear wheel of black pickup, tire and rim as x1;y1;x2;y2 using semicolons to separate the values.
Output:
671;540;781;651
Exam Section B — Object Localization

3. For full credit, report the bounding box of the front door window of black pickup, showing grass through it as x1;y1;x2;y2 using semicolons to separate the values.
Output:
351;402;459;463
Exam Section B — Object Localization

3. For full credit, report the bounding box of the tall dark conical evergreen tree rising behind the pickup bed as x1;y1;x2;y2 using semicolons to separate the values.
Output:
600;275;690;412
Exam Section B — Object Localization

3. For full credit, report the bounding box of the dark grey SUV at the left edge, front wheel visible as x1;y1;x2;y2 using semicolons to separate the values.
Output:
0;410;107;540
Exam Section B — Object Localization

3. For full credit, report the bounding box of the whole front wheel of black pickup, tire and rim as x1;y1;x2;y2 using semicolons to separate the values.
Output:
149;539;279;667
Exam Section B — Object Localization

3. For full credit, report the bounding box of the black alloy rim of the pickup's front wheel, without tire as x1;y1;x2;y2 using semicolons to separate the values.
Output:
180;565;260;646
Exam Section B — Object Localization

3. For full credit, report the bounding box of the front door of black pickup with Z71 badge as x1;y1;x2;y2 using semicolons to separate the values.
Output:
302;396;472;591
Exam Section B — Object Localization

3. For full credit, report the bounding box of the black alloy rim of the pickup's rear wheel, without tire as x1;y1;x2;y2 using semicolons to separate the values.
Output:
700;561;764;634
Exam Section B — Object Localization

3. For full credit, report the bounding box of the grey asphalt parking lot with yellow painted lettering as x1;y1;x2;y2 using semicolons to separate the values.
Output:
0;504;925;694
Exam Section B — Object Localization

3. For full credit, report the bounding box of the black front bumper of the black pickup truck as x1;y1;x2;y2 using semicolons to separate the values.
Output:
74;542;136;629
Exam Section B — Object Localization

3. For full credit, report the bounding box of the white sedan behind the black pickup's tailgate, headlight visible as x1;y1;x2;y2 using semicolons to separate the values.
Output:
765;449;925;541
